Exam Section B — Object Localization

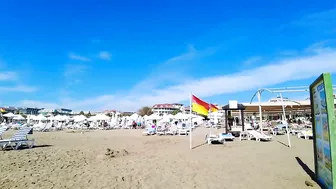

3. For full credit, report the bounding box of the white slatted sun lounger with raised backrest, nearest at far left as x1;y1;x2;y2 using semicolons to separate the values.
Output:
0;127;35;150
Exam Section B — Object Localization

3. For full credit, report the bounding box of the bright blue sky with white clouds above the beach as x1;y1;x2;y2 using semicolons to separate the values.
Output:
0;0;336;111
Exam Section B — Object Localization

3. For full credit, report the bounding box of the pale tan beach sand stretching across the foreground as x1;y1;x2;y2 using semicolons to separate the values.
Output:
0;128;319;189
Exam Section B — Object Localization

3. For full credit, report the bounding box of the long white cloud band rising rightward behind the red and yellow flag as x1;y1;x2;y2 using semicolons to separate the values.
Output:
17;43;336;111
